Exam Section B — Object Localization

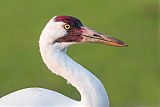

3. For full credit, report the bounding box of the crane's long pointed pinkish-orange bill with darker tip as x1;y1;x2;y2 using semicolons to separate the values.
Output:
82;27;128;47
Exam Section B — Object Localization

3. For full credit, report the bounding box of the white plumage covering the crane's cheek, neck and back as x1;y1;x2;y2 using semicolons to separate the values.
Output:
0;16;127;107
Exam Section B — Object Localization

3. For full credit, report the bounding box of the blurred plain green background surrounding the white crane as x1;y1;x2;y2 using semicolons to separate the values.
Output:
0;0;160;107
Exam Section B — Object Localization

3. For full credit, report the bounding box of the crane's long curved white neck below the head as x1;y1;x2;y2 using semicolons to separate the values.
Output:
40;38;109;107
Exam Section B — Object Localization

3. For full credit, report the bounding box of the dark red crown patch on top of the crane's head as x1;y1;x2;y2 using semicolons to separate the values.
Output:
54;16;83;28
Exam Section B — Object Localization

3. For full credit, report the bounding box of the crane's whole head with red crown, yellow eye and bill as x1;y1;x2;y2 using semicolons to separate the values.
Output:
42;16;128;47
